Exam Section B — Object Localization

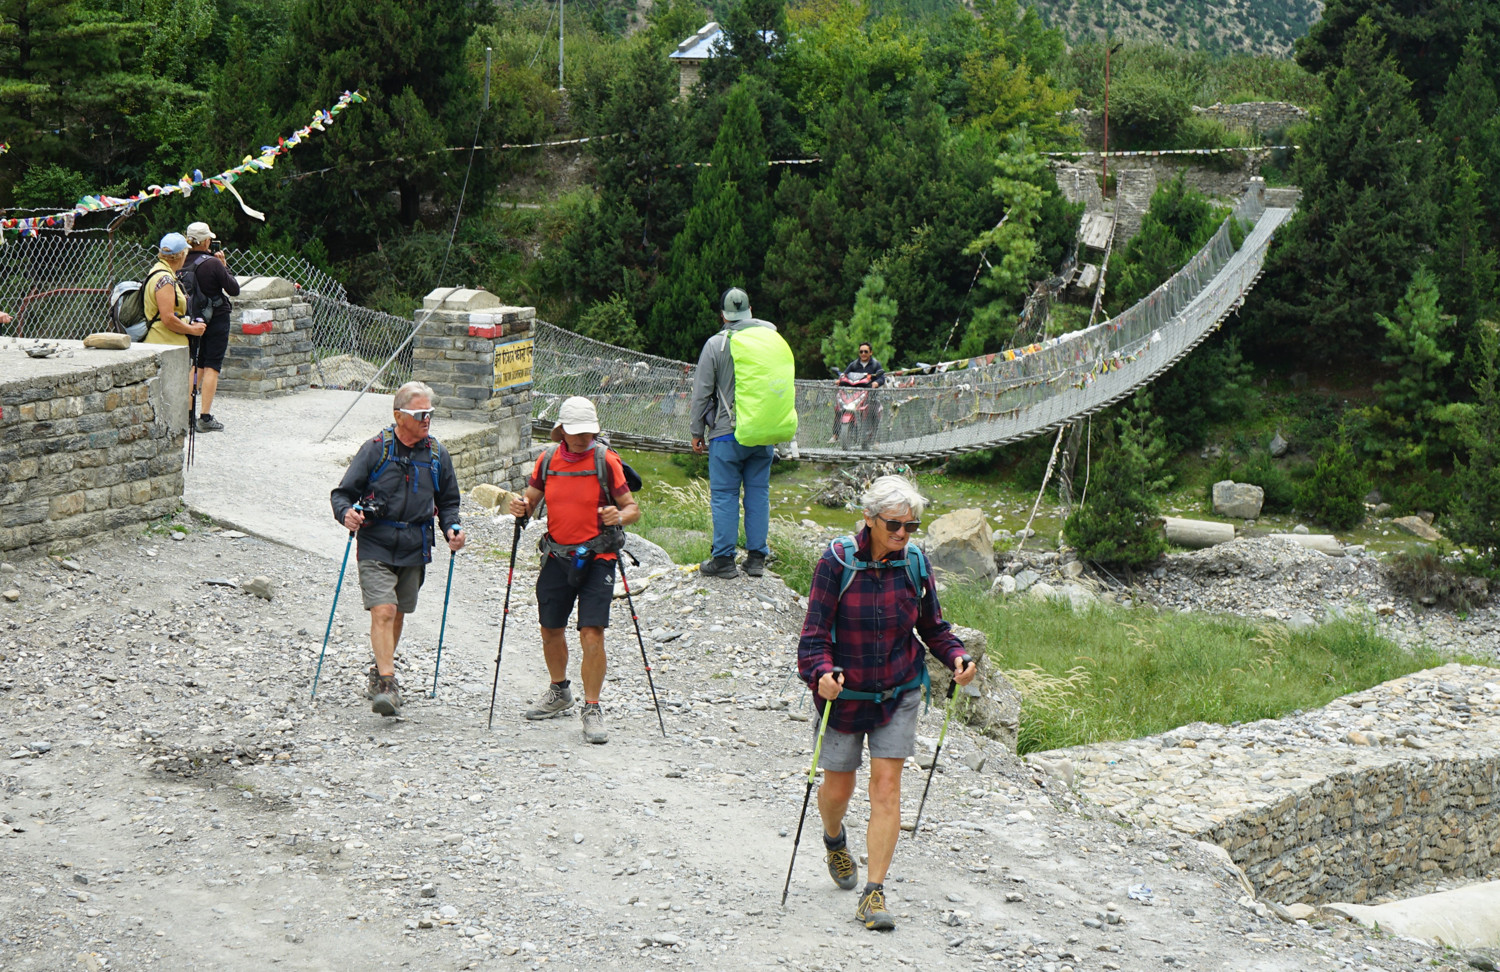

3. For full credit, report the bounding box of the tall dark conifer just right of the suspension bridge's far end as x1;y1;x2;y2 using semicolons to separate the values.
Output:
1257;20;1437;356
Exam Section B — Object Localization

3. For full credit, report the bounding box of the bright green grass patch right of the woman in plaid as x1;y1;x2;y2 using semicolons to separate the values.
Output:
944;588;1484;753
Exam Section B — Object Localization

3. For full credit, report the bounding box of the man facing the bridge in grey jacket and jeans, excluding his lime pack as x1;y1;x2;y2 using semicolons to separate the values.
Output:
689;287;776;578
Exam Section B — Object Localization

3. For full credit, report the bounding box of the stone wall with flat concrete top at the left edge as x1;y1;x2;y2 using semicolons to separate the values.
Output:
0;341;188;557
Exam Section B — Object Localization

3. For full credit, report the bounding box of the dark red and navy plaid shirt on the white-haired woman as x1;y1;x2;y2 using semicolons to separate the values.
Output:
797;528;965;732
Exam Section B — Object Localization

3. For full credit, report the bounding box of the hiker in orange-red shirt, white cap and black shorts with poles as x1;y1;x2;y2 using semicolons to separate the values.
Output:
510;396;641;743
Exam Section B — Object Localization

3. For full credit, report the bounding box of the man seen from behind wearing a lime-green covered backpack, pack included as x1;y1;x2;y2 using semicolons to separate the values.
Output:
689;287;797;578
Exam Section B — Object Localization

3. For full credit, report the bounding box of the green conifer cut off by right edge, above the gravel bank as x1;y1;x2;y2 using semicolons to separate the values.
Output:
1446;321;1500;570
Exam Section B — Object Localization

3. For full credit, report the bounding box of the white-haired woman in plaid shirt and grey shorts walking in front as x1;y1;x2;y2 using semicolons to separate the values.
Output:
797;476;975;930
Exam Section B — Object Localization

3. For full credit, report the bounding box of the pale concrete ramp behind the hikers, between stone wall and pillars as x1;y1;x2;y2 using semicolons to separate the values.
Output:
185;389;489;560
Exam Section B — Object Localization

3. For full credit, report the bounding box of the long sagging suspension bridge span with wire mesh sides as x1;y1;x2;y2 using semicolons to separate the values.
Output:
533;191;1287;459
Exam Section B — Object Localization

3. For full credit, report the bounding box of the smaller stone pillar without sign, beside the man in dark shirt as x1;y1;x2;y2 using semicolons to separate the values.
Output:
219;276;312;398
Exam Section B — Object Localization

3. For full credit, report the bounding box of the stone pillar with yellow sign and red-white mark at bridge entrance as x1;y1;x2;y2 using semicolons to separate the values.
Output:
411;287;537;489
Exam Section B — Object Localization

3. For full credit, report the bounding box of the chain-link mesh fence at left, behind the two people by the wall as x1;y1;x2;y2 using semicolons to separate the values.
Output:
0;231;416;392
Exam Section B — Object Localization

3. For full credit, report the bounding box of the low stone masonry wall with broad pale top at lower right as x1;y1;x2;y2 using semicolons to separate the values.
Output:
1046;665;1500;903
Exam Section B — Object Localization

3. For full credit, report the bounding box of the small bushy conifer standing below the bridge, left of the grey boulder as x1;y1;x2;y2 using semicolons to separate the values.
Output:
1062;392;1170;569
